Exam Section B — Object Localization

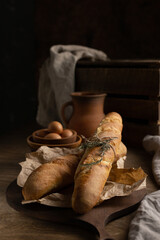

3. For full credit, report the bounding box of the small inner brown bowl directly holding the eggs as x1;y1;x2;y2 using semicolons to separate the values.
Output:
32;129;77;144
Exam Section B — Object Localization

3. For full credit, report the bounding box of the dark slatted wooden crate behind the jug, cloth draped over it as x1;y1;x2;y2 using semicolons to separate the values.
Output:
75;60;160;147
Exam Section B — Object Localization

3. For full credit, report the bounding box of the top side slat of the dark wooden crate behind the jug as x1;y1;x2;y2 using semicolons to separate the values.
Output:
75;67;160;97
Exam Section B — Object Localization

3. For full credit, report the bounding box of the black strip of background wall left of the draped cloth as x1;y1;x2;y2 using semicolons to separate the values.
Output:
0;0;36;131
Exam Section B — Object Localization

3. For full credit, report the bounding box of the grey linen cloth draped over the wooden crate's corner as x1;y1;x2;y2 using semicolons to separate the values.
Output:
36;45;109;127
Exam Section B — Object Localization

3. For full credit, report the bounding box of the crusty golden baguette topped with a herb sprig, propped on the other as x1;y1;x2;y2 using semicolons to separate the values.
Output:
72;112;126;214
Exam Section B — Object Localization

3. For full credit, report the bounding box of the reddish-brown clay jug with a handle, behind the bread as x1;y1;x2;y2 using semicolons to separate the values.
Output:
61;92;106;138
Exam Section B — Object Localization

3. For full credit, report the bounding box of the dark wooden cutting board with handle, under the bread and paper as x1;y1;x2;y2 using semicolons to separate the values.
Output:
6;180;146;240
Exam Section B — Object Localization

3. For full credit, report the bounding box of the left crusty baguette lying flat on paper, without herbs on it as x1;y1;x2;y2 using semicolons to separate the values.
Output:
22;154;80;200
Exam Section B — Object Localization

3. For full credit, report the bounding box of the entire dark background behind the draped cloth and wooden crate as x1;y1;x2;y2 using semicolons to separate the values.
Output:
0;0;160;132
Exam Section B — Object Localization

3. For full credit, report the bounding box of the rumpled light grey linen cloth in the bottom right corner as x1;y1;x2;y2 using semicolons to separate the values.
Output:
128;190;160;240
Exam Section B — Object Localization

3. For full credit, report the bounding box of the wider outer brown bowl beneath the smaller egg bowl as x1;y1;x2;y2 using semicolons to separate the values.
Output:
27;135;82;151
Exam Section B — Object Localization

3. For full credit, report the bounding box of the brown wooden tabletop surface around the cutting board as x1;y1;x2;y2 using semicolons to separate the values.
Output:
0;124;158;240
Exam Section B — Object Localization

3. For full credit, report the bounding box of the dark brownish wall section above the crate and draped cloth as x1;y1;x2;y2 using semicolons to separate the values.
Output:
35;0;160;70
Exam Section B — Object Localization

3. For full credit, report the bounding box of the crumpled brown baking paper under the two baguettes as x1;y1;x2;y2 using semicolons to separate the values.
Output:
17;146;147;208
